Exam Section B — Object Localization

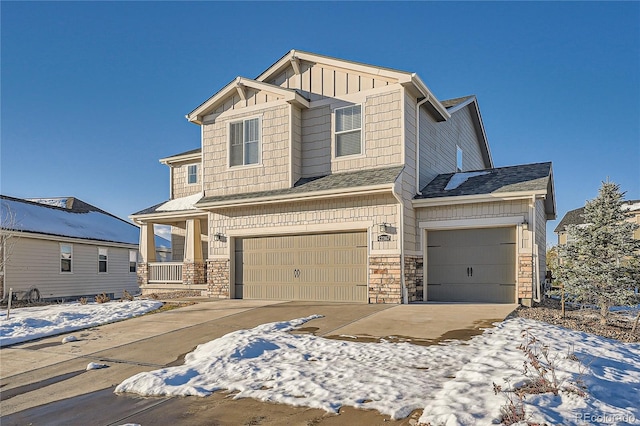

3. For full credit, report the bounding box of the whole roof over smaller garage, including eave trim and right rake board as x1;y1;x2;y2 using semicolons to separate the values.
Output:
414;162;556;218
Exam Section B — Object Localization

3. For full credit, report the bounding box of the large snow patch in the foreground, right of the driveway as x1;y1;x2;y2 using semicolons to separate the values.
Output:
115;316;640;425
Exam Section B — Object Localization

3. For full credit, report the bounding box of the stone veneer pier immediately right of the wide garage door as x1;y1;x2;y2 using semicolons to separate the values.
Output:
369;256;402;303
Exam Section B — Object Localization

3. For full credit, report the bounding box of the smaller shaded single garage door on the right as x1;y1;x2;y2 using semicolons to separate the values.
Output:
426;227;516;303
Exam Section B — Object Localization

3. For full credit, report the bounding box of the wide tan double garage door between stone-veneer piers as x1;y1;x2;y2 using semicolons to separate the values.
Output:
235;232;368;303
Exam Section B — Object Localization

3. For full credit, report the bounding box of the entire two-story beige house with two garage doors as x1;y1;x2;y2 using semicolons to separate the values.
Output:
131;50;555;303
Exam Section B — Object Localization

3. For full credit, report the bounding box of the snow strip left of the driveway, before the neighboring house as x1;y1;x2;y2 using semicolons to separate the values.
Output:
0;300;162;346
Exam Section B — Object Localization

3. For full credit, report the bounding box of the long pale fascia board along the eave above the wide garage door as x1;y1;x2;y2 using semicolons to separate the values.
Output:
197;184;393;209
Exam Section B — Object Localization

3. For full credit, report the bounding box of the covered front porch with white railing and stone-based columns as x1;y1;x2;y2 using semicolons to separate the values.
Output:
136;214;209;295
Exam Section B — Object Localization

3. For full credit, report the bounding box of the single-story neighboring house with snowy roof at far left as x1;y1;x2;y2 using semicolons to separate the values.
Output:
0;196;140;299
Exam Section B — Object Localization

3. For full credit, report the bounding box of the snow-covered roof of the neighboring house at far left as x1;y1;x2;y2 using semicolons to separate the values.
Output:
0;195;140;246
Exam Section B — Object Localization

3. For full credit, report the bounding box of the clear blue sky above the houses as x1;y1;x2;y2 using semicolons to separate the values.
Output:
0;1;640;246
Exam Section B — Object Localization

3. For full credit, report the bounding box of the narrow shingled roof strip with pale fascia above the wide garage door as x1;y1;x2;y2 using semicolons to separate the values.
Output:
195;166;403;208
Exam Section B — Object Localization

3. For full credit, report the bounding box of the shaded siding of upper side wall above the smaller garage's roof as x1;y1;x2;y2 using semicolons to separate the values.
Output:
420;102;485;188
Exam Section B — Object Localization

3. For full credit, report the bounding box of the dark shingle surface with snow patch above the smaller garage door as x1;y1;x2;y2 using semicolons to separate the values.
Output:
415;163;551;199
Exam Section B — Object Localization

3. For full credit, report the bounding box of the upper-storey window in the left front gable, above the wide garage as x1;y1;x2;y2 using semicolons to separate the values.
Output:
229;118;260;167
